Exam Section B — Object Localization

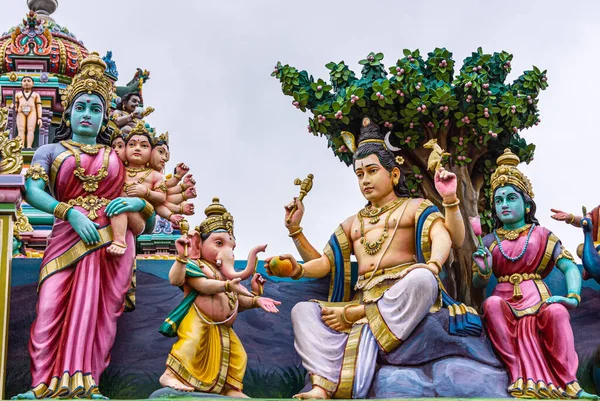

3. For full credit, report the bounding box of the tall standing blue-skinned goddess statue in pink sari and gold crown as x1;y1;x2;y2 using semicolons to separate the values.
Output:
16;53;154;399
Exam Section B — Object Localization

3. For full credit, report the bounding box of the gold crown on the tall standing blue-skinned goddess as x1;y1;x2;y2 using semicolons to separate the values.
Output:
62;52;113;110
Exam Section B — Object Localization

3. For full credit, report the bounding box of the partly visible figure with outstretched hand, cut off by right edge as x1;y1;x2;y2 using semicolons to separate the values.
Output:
551;206;600;283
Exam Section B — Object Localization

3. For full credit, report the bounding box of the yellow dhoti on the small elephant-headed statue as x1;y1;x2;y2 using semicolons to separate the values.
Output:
167;305;248;394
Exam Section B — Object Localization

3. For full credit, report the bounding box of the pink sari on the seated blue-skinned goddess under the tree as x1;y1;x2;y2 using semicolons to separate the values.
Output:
483;226;581;398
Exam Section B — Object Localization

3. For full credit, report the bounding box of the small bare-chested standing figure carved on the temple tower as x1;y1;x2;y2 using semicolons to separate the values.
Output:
15;76;42;148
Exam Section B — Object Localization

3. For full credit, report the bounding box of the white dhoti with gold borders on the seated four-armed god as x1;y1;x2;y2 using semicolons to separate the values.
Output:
292;268;439;398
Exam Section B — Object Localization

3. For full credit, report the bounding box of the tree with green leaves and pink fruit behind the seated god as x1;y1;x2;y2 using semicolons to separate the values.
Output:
271;48;548;303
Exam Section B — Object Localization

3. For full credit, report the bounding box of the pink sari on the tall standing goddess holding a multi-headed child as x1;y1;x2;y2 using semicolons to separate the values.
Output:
29;148;135;398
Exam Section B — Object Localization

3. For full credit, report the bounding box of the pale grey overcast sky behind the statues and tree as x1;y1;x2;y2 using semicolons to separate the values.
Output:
0;0;600;259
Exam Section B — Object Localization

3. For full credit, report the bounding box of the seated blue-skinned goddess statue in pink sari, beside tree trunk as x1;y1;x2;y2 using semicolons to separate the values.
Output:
473;149;597;398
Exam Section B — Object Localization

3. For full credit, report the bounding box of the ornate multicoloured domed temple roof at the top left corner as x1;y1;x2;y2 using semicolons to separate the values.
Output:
0;0;89;77
